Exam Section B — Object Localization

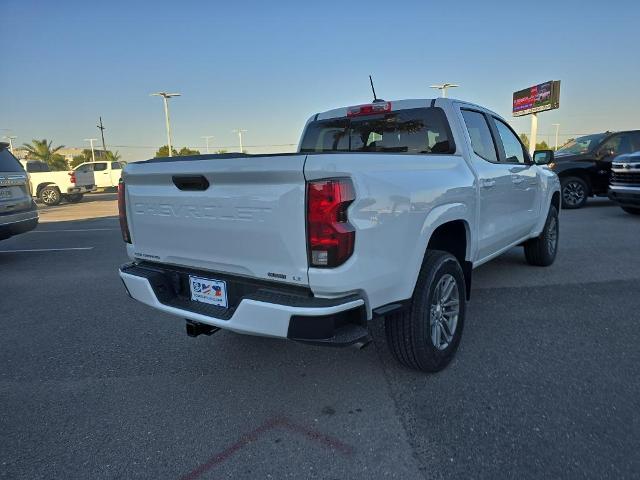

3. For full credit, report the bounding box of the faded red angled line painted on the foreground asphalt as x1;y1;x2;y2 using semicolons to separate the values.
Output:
180;417;353;480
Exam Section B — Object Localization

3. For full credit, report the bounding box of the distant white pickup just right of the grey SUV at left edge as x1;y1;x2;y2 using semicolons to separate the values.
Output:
20;160;95;206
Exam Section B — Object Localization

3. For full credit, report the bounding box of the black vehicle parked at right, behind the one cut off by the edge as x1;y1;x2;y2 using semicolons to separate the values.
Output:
549;130;640;208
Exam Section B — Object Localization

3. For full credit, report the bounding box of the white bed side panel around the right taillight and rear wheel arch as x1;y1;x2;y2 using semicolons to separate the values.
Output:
305;153;476;313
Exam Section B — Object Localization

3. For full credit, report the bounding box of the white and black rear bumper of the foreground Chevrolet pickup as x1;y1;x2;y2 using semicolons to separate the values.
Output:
120;264;368;346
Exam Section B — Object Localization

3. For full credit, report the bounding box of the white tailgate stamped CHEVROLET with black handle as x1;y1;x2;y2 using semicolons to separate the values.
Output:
123;155;308;285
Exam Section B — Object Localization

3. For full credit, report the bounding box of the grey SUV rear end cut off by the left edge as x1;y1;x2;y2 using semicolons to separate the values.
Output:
0;142;38;240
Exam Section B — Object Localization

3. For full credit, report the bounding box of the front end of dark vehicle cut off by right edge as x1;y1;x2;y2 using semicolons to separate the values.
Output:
609;151;640;215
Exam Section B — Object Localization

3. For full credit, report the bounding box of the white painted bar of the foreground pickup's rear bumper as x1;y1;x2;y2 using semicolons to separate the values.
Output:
120;272;364;338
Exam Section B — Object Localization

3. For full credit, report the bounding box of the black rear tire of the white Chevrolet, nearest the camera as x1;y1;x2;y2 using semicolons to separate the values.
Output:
385;250;466;372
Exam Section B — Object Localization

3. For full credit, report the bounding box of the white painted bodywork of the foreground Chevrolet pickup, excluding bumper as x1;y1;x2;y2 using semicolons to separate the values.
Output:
124;99;559;334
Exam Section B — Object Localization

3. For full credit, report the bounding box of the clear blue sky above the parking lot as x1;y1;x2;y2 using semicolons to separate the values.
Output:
0;0;640;160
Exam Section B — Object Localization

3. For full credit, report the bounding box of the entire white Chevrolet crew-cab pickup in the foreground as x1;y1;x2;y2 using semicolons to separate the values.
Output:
118;99;560;371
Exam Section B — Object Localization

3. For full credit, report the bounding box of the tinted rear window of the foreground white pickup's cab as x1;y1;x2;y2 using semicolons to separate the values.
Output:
300;107;455;154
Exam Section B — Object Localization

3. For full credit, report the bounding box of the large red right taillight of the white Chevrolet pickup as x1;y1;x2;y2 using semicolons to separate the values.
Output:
307;178;356;268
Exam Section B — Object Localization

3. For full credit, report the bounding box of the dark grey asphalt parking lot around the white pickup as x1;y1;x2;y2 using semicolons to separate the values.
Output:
0;195;640;479
